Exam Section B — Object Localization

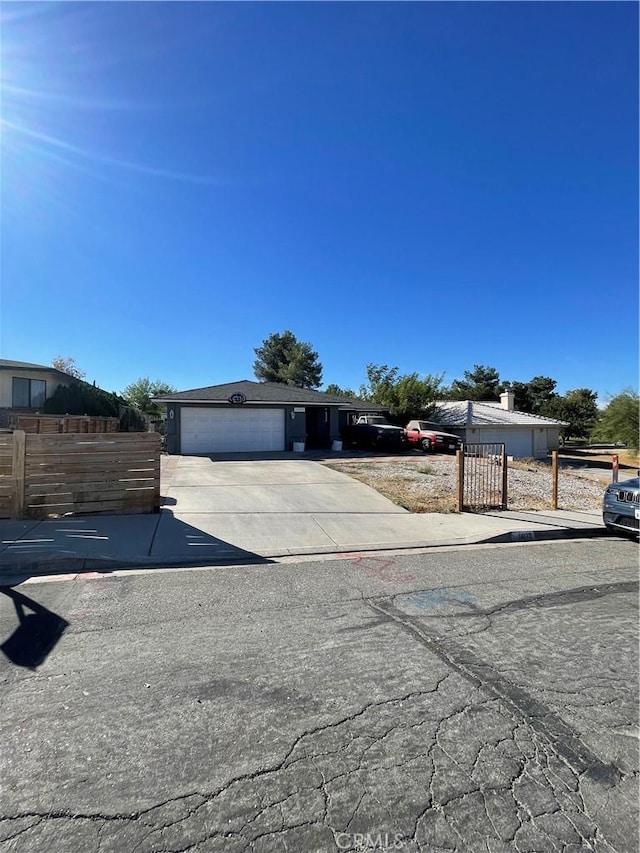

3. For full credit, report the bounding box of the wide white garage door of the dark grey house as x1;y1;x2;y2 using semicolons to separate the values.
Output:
180;406;284;454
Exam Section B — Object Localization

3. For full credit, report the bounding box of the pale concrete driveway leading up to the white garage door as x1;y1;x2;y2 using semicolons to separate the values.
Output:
152;455;414;558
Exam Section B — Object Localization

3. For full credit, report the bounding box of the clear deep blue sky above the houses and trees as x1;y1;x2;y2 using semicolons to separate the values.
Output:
0;2;638;398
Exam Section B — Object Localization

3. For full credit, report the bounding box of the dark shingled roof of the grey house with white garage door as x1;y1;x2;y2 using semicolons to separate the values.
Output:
154;379;385;412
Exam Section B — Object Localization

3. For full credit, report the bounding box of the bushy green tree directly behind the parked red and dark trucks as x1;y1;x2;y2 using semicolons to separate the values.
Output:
360;363;442;424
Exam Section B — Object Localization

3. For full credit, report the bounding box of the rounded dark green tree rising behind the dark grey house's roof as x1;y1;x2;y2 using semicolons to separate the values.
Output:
253;330;322;388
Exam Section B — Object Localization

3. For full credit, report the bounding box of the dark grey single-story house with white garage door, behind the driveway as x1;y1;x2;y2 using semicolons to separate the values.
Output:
154;379;384;455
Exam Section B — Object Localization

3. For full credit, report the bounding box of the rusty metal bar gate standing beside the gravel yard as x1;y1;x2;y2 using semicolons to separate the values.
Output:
458;444;507;510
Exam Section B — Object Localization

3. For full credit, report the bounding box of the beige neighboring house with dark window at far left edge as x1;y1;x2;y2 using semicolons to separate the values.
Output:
0;359;73;427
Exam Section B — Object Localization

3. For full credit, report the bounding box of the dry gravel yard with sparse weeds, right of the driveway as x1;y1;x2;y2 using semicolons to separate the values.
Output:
324;451;611;512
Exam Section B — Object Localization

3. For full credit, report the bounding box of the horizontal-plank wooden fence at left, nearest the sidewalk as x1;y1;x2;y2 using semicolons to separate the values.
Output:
0;430;161;518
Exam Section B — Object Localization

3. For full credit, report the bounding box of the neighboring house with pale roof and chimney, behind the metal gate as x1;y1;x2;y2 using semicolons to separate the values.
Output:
432;391;567;459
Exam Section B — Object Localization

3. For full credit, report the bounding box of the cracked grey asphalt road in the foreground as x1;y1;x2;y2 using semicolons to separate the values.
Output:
0;537;639;853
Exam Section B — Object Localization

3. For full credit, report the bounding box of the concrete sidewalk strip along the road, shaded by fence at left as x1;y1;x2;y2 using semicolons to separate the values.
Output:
0;507;606;585
